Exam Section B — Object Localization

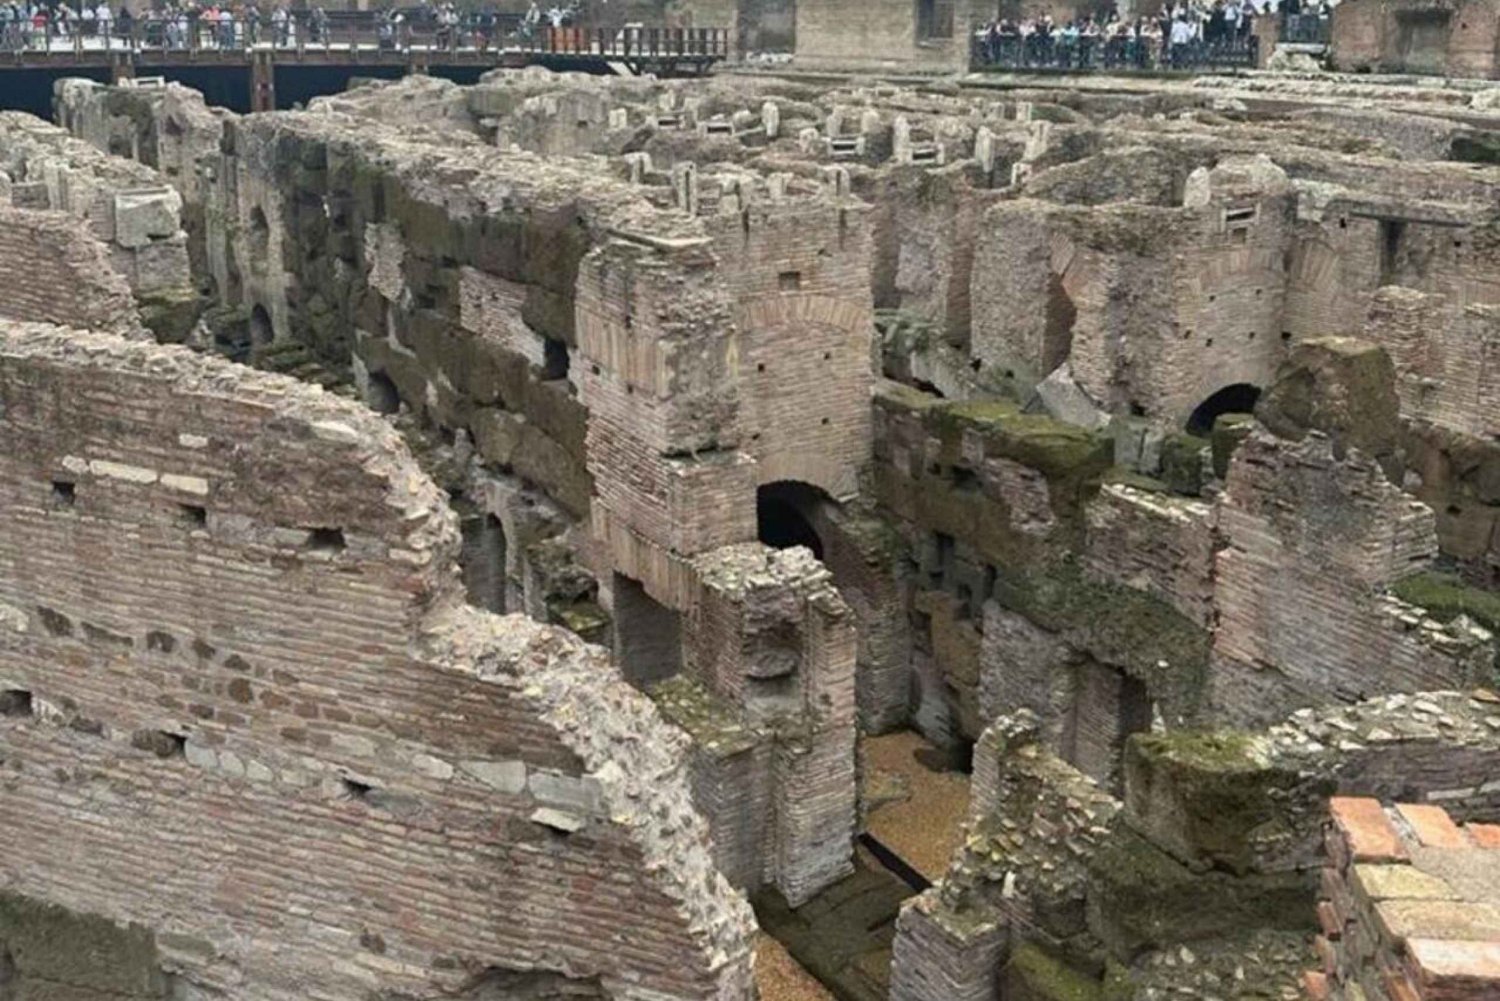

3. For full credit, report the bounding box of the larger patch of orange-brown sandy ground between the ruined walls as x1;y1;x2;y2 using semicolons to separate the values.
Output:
864;731;969;882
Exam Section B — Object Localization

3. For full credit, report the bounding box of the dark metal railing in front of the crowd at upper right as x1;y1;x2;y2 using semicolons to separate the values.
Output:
974;35;1260;72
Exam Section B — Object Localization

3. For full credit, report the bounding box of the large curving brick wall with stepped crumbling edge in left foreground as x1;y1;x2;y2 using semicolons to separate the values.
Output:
0;324;752;999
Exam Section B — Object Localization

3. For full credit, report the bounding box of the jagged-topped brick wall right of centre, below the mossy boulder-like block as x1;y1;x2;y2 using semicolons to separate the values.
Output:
1211;432;1491;720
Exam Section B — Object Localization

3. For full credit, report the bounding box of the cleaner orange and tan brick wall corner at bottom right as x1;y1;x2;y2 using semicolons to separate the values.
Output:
1305;798;1500;1001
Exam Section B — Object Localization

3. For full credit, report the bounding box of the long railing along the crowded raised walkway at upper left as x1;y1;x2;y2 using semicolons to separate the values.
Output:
0;11;729;59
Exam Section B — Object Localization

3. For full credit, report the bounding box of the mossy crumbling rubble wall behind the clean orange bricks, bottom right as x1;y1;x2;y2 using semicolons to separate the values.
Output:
893;692;1500;999
